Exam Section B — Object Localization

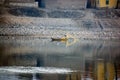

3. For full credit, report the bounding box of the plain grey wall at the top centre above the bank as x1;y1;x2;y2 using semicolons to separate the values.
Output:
45;0;87;9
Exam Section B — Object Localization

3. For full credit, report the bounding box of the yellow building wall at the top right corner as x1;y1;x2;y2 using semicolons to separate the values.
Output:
97;0;117;8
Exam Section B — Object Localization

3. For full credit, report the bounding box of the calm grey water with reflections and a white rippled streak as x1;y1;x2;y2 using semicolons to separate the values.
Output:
0;37;120;80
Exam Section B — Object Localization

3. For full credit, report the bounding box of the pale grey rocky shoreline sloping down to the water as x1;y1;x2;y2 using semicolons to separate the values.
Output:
0;6;120;40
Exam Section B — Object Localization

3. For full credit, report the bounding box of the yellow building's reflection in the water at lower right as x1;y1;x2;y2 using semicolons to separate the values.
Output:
96;60;116;80
